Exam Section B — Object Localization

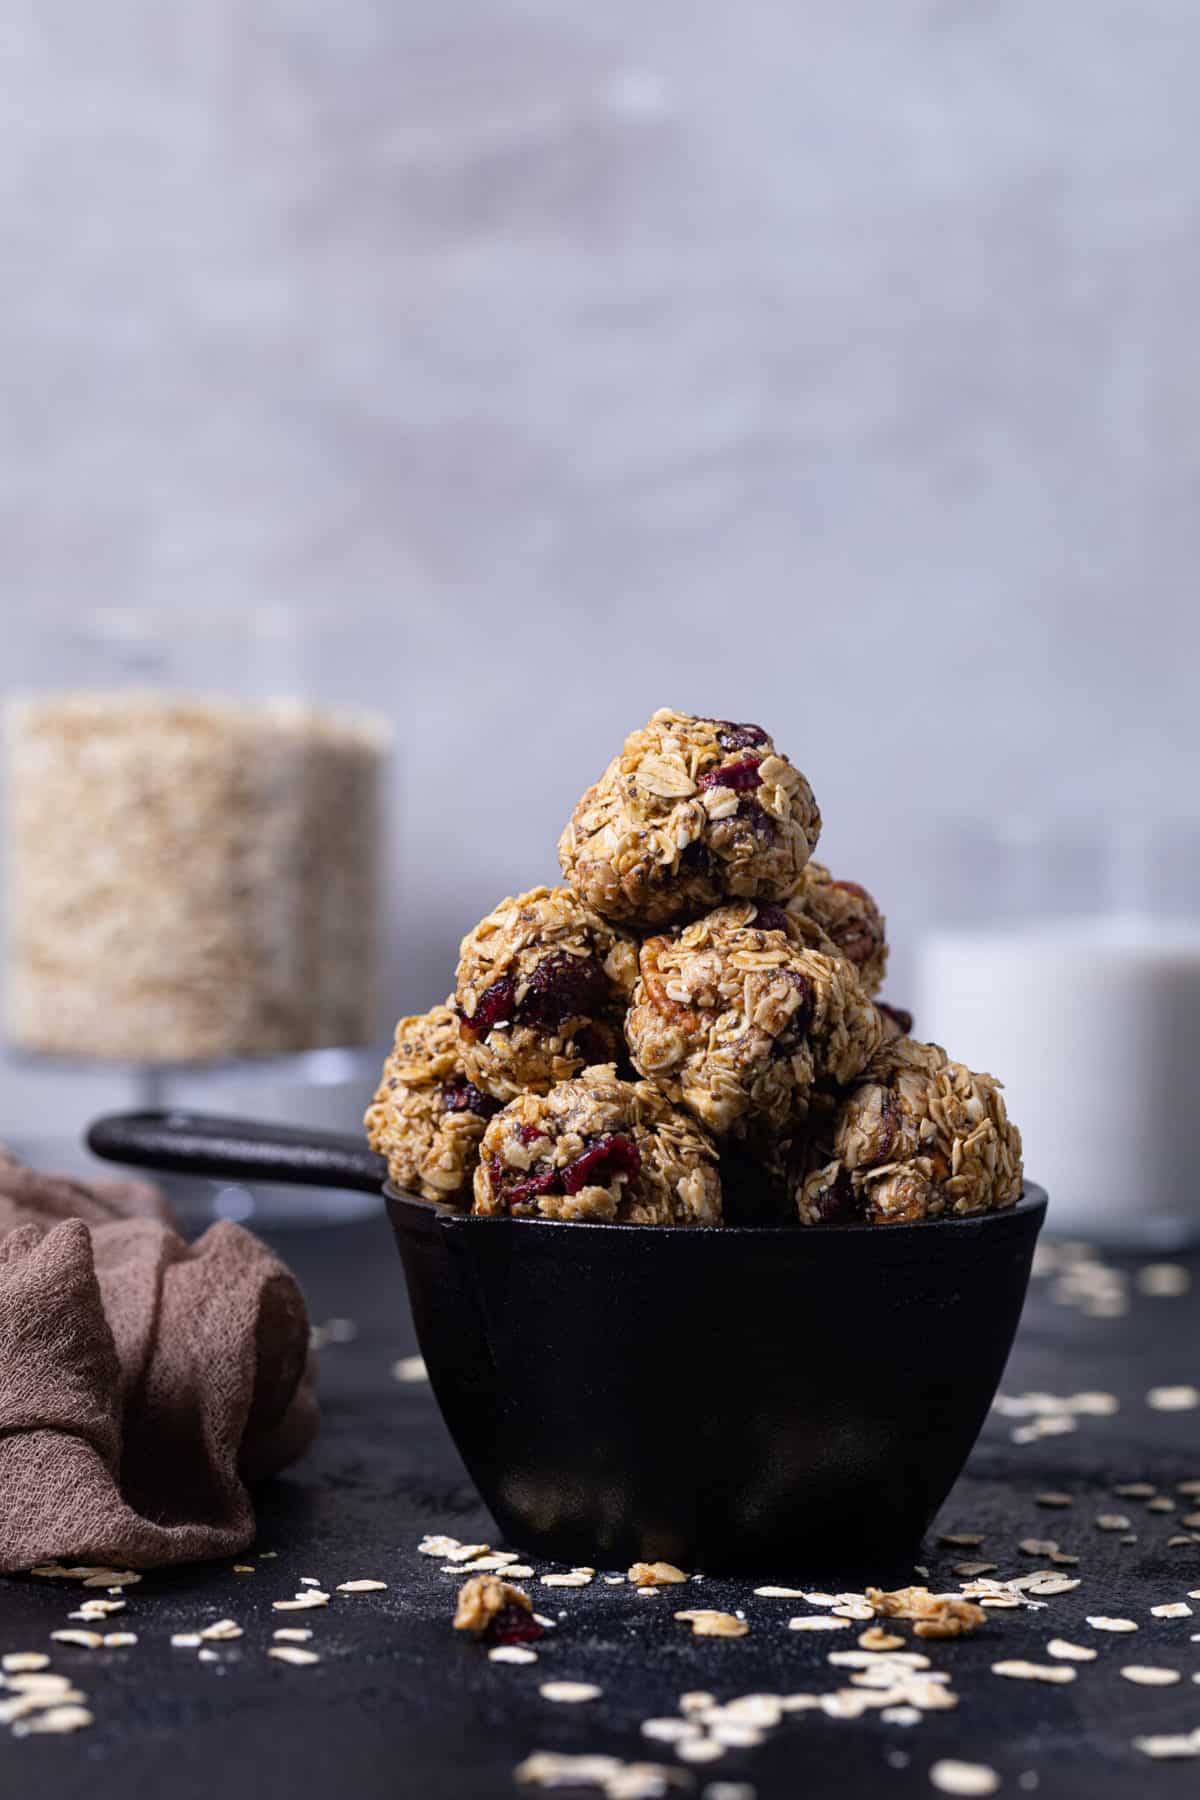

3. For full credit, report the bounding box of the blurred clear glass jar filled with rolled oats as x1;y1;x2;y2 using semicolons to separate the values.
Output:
4;610;387;1064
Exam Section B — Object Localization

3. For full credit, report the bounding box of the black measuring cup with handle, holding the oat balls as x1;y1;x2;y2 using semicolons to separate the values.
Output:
88;1112;1045;1579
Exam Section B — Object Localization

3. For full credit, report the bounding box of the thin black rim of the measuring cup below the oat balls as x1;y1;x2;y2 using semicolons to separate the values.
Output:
383;1181;1049;1247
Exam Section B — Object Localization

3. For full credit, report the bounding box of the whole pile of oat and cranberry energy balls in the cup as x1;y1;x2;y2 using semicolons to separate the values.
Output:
365;709;1022;1226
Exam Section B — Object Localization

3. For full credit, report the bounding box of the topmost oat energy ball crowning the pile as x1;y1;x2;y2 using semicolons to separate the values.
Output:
558;707;820;925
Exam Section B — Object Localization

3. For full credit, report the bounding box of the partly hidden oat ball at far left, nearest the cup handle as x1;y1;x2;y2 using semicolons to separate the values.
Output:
363;1004;500;1206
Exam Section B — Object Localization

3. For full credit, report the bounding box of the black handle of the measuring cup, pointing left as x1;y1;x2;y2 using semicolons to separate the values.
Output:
88;1112;387;1193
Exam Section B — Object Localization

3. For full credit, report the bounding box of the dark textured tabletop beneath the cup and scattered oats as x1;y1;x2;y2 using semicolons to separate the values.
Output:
0;1217;1200;1800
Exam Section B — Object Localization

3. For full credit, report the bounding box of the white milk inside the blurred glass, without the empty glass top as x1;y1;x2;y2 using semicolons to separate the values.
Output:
916;916;1200;1246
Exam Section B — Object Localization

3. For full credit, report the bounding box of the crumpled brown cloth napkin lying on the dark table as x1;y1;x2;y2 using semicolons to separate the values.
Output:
0;1147;318;1570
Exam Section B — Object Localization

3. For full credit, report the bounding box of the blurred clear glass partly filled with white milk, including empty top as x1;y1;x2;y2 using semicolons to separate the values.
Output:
916;817;1200;1249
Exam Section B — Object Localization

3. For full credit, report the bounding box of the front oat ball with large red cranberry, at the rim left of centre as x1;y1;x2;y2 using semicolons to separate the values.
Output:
473;1064;721;1226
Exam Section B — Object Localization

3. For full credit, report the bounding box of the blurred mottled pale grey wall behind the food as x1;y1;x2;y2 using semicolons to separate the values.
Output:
0;0;1200;1123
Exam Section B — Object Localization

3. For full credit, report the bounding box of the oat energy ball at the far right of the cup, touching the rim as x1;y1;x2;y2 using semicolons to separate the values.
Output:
795;1037;1022;1226
